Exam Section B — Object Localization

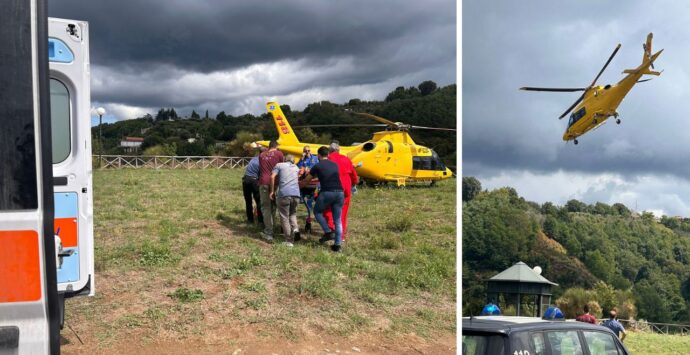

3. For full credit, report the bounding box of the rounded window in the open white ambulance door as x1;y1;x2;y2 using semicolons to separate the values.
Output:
50;79;71;164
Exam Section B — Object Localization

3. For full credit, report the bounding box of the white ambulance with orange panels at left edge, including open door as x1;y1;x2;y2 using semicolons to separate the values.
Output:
0;0;95;355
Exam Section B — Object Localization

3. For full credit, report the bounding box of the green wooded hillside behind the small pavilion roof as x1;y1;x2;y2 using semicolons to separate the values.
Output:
462;178;690;323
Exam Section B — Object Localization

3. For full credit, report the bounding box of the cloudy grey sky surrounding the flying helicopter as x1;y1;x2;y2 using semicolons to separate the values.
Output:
462;1;690;216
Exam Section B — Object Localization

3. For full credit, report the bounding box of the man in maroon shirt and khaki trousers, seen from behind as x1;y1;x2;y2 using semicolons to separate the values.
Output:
259;141;285;242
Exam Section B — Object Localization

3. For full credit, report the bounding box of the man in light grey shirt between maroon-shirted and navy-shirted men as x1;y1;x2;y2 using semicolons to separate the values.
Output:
269;154;300;247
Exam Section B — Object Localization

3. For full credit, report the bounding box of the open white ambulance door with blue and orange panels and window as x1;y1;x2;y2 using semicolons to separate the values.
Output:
48;18;94;297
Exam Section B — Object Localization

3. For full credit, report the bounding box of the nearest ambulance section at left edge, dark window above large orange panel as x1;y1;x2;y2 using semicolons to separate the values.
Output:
0;0;60;354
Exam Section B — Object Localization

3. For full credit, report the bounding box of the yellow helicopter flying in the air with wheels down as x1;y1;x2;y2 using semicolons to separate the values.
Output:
520;33;664;144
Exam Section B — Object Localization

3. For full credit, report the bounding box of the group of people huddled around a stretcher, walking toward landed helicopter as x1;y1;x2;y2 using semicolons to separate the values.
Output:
242;141;359;252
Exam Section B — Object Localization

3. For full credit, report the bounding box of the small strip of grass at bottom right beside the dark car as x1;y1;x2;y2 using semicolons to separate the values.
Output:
625;332;690;355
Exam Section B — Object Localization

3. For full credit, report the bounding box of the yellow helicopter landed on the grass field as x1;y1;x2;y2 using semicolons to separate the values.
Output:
256;102;455;186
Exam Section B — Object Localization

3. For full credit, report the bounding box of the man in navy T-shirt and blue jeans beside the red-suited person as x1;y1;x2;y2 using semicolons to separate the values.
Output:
300;147;345;253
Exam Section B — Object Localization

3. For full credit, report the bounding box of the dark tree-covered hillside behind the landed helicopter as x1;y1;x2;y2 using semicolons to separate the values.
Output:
92;81;457;166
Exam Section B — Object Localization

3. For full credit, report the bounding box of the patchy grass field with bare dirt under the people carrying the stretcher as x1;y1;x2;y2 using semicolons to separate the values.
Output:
62;170;456;353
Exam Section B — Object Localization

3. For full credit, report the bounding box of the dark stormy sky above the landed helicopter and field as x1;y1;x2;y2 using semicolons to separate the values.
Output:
49;0;457;120
